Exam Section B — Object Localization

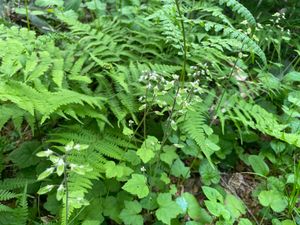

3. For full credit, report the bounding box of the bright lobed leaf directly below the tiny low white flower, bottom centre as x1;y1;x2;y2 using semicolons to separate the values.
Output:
122;174;149;198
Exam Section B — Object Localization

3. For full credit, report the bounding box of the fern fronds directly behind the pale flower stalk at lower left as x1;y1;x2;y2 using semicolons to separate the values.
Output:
49;126;136;224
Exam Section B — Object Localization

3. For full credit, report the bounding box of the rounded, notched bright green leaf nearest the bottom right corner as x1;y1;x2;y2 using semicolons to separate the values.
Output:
258;190;288;212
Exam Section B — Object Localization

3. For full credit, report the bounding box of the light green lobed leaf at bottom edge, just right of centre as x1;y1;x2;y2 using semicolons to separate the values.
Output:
155;193;182;225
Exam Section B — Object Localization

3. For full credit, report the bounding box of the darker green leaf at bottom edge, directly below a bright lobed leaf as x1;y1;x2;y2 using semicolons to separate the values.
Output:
120;201;144;225
